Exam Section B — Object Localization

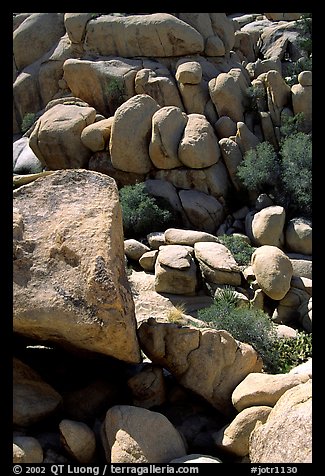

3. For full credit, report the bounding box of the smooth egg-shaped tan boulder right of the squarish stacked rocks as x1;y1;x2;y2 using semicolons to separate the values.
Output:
251;245;293;300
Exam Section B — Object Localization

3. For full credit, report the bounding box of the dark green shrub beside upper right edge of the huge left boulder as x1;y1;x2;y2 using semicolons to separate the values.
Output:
119;183;177;237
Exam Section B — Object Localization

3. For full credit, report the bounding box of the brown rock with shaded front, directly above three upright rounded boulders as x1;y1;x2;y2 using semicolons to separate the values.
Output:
134;68;183;110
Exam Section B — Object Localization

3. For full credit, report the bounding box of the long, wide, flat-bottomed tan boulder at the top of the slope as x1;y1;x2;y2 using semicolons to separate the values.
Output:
84;13;203;58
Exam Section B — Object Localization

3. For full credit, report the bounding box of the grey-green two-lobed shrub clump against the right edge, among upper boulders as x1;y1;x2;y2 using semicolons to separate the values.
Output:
237;132;312;218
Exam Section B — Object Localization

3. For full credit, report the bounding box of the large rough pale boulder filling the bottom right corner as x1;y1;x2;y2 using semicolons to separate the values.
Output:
249;380;312;464
